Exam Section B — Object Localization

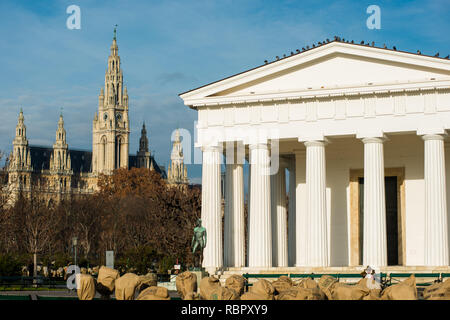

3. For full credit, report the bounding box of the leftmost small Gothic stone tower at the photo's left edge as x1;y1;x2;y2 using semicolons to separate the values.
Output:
8;109;33;190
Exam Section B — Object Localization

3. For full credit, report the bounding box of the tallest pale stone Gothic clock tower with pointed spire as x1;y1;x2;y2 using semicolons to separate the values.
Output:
92;29;130;174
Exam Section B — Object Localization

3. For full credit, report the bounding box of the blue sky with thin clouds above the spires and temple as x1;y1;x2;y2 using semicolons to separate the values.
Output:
0;0;450;182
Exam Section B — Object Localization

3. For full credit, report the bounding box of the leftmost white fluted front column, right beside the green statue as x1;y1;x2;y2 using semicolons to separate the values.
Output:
202;146;223;272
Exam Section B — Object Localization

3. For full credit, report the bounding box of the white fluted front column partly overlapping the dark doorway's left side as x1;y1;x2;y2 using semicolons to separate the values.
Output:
362;138;387;267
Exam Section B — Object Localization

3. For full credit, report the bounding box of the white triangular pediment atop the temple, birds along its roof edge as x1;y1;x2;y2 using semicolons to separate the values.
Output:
180;42;450;105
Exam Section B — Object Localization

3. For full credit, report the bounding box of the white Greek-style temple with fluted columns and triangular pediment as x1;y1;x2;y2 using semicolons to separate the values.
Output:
180;41;450;271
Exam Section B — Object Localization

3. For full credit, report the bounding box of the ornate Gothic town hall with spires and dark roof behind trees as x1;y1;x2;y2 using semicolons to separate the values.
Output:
3;35;166;201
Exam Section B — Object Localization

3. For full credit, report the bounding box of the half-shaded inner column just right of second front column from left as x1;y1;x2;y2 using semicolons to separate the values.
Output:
270;163;288;267
